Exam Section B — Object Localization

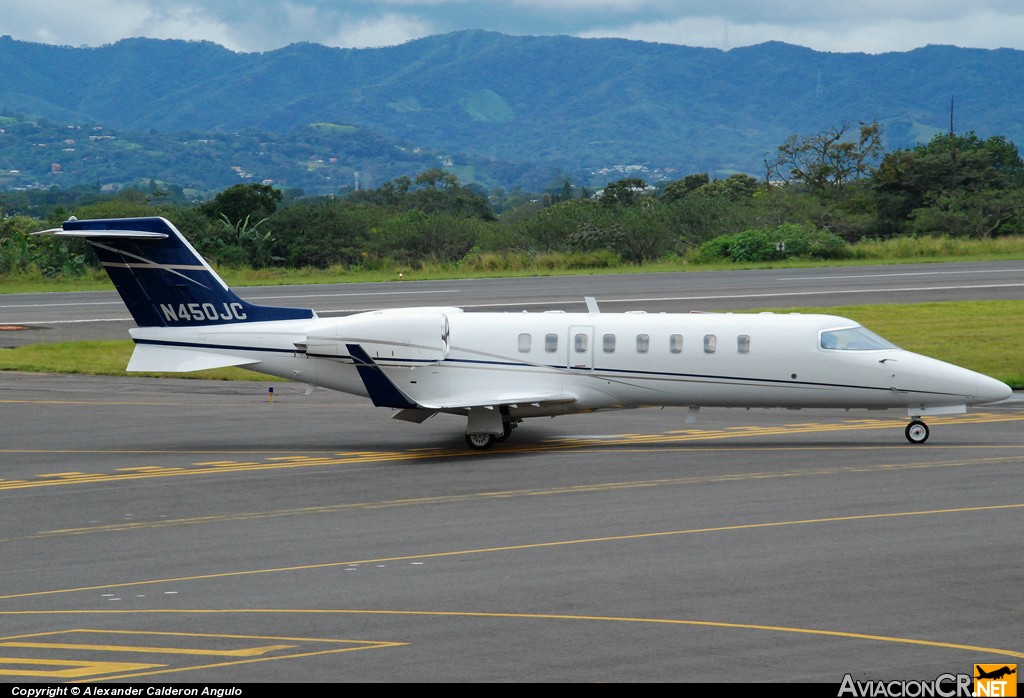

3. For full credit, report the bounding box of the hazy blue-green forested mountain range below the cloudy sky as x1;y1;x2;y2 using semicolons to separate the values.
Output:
0;31;1024;193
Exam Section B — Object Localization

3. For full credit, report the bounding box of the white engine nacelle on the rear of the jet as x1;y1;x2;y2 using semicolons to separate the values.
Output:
305;308;452;365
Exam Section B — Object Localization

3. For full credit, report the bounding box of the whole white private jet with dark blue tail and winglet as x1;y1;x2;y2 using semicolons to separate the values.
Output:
36;217;1011;449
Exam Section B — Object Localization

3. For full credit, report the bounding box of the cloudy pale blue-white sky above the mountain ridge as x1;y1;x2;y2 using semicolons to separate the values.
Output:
0;0;1024;53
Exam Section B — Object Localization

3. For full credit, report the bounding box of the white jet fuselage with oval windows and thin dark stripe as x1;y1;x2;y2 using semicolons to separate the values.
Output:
125;308;1009;419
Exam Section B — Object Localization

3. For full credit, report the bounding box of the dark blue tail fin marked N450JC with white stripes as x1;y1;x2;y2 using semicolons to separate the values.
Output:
35;217;316;328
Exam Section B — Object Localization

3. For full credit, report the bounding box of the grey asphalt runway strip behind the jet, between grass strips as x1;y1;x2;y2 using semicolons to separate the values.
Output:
0;261;1024;348
